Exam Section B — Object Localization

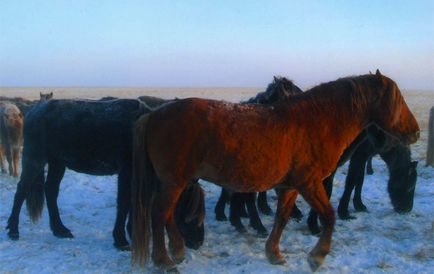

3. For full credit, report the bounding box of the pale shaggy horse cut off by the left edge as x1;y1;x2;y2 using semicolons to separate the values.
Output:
0;102;24;177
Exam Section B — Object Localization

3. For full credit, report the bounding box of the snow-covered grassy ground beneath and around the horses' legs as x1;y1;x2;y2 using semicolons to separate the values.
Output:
0;89;434;273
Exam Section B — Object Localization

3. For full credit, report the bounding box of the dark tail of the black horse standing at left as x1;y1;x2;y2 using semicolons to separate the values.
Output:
26;170;45;223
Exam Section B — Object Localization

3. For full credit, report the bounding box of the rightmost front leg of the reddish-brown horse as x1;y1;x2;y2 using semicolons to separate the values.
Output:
299;181;335;271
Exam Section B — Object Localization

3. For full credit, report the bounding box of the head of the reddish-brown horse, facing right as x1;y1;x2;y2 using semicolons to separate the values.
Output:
367;70;420;145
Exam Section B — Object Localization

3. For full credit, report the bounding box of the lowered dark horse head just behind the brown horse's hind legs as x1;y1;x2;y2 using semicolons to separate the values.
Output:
175;182;205;249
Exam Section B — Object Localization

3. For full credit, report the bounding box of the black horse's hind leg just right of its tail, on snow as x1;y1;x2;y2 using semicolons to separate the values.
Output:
45;162;74;238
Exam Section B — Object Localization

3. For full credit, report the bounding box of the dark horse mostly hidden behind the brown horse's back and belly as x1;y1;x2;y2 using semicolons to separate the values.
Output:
214;76;302;237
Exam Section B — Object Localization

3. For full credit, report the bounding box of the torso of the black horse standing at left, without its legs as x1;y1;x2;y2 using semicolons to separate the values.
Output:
24;99;144;175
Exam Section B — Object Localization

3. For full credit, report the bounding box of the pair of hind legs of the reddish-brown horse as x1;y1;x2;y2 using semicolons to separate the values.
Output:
152;183;189;271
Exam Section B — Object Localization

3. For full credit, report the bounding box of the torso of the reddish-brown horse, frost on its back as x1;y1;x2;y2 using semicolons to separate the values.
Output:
147;98;318;191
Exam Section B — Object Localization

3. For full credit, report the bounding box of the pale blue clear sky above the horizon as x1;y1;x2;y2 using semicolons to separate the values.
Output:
0;0;434;90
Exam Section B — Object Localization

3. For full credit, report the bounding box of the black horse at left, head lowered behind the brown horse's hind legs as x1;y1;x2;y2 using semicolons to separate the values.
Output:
7;99;204;250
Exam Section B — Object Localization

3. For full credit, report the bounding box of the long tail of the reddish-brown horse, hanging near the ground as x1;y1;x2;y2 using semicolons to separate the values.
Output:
131;114;156;266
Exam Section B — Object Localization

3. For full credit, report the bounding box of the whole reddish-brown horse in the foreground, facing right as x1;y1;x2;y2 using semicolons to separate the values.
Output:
132;71;419;270
